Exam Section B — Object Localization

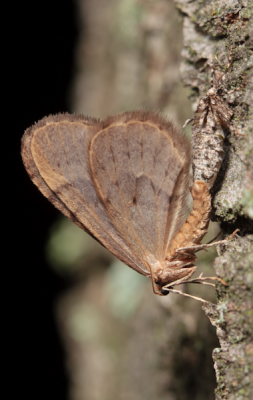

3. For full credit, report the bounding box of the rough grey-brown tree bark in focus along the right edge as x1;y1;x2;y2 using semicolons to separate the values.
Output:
176;0;253;400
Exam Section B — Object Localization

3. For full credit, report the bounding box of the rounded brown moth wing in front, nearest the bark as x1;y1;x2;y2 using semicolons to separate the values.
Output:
90;112;190;268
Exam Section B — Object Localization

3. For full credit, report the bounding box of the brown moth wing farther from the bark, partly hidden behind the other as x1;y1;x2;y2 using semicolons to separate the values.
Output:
22;114;150;275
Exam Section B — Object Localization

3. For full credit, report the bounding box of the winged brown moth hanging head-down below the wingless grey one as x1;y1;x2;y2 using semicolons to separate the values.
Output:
22;111;226;295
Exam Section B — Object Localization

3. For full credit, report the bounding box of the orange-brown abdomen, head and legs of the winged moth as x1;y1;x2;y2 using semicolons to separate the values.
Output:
158;181;233;301
